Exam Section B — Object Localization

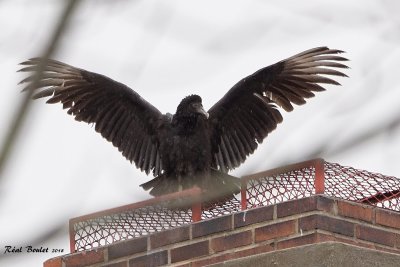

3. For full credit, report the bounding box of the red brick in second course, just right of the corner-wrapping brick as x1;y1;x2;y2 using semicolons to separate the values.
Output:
356;225;396;247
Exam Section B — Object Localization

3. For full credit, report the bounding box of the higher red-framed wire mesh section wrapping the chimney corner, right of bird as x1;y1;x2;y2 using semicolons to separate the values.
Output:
242;159;400;211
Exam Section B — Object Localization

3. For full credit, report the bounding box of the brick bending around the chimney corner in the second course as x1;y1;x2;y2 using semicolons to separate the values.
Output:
299;214;354;236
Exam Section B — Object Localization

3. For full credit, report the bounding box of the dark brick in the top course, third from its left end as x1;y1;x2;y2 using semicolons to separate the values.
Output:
108;236;147;260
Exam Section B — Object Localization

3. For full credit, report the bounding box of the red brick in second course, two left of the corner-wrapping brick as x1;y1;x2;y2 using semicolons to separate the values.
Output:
211;231;252;252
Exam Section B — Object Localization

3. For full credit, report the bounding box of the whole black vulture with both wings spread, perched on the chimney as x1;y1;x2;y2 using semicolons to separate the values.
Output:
20;47;347;204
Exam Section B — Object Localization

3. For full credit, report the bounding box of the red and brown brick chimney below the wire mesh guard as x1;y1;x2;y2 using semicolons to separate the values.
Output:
44;161;400;267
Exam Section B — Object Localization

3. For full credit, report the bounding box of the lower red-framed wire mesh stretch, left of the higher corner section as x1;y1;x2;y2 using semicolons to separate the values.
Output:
70;188;240;252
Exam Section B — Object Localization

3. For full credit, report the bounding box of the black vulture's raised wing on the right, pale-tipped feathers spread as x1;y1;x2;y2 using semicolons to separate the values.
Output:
208;47;347;171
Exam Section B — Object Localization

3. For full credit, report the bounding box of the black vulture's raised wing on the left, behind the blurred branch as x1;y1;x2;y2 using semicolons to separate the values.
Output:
20;58;163;175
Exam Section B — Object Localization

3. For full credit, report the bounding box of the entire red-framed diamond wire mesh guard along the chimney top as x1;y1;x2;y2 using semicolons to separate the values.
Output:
70;159;400;252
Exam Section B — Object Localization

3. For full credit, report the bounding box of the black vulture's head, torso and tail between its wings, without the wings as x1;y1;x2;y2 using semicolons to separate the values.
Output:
141;95;240;200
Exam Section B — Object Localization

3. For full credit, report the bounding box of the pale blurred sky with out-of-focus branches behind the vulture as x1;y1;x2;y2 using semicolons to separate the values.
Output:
0;0;400;267
